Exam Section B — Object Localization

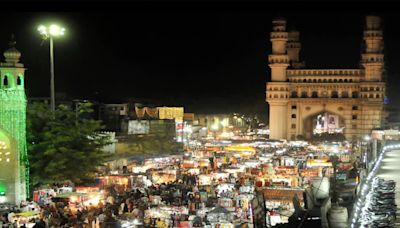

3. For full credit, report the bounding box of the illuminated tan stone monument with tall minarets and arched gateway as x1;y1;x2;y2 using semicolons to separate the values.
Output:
266;16;386;140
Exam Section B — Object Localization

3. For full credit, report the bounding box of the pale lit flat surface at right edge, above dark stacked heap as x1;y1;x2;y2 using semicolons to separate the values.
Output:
376;150;400;227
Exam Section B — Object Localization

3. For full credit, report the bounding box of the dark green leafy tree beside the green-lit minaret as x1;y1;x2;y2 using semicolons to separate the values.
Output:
27;102;110;187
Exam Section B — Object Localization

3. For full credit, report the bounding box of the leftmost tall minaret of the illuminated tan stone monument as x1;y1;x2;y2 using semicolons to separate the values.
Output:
267;18;289;139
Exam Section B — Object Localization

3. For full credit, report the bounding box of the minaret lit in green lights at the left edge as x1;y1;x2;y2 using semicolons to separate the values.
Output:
0;37;29;204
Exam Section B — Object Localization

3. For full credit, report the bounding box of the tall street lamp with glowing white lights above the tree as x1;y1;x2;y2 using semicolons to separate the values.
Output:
38;24;65;112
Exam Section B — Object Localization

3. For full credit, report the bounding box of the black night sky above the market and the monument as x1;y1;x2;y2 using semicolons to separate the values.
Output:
0;2;400;121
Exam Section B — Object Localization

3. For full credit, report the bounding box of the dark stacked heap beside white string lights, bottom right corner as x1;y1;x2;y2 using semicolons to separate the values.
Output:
361;177;397;227
